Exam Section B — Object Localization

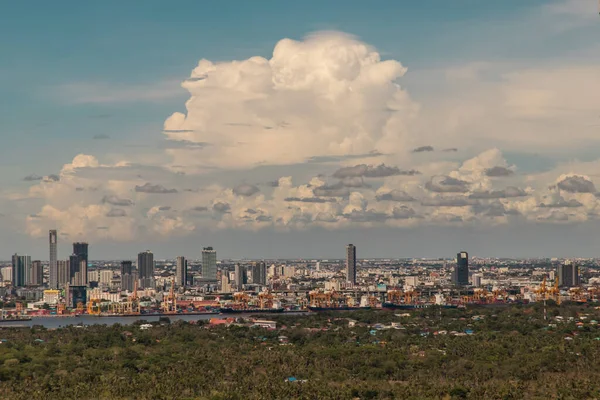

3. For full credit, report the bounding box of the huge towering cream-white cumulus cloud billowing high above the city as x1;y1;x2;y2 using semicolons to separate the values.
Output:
164;32;418;168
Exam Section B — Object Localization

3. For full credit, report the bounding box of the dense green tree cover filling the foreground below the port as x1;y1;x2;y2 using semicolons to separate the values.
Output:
0;304;600;400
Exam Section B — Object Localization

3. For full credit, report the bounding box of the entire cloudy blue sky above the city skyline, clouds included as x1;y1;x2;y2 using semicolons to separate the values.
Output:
0;0;600;259
